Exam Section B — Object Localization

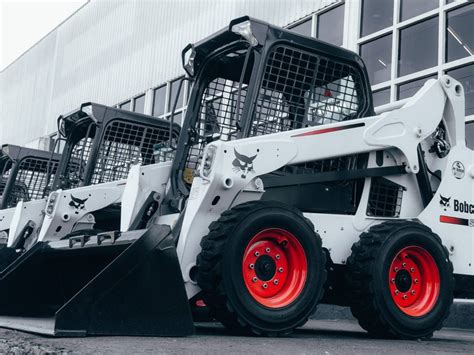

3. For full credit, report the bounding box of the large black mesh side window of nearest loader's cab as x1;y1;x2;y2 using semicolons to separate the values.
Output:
250;45;364;135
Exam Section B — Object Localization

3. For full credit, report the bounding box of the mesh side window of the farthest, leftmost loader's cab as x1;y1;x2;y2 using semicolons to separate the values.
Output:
7;158;58;208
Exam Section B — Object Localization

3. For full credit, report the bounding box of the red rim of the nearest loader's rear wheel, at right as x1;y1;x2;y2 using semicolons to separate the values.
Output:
388;246;440;317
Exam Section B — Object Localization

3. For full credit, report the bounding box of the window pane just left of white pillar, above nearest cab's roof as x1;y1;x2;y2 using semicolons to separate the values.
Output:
317;5;344;46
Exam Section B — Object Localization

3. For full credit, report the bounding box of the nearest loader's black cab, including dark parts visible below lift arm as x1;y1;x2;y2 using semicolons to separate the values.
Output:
170;17;374;213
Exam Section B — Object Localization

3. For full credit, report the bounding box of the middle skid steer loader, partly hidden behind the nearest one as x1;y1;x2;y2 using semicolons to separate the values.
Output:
0;103;179;269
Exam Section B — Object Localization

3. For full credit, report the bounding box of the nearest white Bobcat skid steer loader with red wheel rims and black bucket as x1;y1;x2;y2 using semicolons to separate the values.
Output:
0;17;474;339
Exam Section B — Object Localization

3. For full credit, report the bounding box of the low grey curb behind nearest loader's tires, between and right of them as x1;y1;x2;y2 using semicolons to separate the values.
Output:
311;299;474;329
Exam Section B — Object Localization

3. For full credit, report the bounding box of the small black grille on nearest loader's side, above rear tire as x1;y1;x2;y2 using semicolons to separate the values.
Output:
367;177;404;218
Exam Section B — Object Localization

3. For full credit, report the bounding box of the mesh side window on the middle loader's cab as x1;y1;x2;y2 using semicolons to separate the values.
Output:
91;120;172;185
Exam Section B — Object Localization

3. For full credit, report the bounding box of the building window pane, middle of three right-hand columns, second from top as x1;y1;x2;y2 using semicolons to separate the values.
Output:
398;17;438;76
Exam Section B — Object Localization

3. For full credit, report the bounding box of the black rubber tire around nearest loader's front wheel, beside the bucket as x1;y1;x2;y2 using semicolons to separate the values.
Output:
197;201;326;336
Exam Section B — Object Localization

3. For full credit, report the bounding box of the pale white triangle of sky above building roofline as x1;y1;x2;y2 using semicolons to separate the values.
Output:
0;0;87;71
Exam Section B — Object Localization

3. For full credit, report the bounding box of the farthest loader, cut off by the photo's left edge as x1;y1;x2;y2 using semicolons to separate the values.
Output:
0;144;60;247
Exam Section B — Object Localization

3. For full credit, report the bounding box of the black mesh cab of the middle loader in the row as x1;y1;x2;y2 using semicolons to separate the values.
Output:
54;103;179;189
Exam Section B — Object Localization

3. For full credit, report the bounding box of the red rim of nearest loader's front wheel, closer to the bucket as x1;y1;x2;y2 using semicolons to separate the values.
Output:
242;228;308;308
